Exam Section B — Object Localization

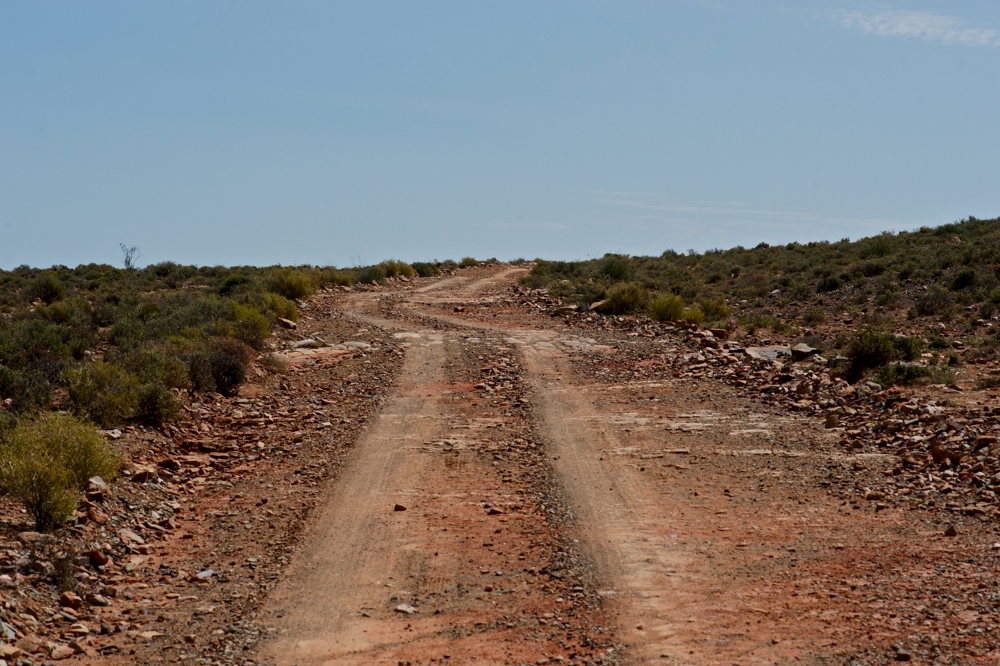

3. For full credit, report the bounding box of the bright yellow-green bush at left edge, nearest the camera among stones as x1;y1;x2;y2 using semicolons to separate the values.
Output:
0;413;119;531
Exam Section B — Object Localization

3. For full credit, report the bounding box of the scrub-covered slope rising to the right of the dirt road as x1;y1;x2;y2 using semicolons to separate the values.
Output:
522;218;1000;385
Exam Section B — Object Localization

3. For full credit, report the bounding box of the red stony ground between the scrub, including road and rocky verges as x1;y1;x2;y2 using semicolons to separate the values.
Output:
0;267;1000;664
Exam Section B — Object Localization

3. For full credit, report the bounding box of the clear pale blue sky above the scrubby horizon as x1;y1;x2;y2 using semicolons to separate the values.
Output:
0;0;1000;268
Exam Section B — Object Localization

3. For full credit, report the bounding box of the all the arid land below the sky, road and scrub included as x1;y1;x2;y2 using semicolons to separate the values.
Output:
0;230;1000;665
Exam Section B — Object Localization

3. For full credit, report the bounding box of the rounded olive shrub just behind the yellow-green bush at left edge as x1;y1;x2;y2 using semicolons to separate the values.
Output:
66;361;138;428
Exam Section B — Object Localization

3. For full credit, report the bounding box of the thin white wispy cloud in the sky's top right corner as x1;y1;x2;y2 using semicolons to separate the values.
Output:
837;11;1000;46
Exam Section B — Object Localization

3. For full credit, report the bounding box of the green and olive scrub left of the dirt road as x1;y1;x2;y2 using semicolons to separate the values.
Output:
0;260;476;529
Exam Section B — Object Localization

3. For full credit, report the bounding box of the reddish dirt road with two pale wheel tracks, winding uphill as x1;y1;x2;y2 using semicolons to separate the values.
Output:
266;269;989;666
